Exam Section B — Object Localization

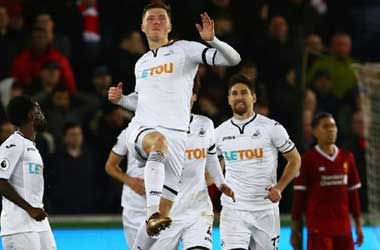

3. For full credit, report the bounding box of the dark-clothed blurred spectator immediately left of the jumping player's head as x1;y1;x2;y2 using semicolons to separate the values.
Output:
108;30;147;93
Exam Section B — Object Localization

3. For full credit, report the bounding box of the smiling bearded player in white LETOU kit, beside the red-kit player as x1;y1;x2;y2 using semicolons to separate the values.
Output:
215;75;301;250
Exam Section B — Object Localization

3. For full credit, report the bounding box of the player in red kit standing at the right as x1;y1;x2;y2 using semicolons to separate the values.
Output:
291;113;363;250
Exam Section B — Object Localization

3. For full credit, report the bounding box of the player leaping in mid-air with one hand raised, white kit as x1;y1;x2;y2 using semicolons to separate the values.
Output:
109;3;240;235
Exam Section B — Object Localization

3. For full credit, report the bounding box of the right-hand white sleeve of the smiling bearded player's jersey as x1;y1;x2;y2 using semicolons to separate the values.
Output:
269;122;295;154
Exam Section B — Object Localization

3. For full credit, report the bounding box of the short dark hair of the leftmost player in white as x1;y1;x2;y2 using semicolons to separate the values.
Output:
7;95;36;127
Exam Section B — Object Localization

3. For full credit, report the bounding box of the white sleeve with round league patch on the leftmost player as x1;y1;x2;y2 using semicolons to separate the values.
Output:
0;138;24;180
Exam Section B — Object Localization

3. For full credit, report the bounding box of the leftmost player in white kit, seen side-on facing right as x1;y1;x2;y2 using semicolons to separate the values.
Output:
0;96;56;250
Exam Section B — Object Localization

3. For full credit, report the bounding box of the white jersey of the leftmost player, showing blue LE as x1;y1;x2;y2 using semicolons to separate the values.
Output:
0;131;50;236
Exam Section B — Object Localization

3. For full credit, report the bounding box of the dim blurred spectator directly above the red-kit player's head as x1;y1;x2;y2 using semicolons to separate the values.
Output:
311;70;340;115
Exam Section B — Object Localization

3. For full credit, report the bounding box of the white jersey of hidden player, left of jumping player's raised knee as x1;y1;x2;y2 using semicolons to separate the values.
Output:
112;128;146;211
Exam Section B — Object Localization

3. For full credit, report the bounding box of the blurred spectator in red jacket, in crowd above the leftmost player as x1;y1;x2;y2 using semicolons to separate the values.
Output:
11;28;76;92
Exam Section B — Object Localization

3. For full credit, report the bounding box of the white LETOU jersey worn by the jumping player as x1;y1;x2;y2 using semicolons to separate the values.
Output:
133;40;220;131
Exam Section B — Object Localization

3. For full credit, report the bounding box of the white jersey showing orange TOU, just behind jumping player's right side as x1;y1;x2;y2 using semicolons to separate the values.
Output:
171;115;216;220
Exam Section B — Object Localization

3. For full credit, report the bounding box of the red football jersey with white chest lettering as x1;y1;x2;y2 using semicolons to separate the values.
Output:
293;146;361;236
